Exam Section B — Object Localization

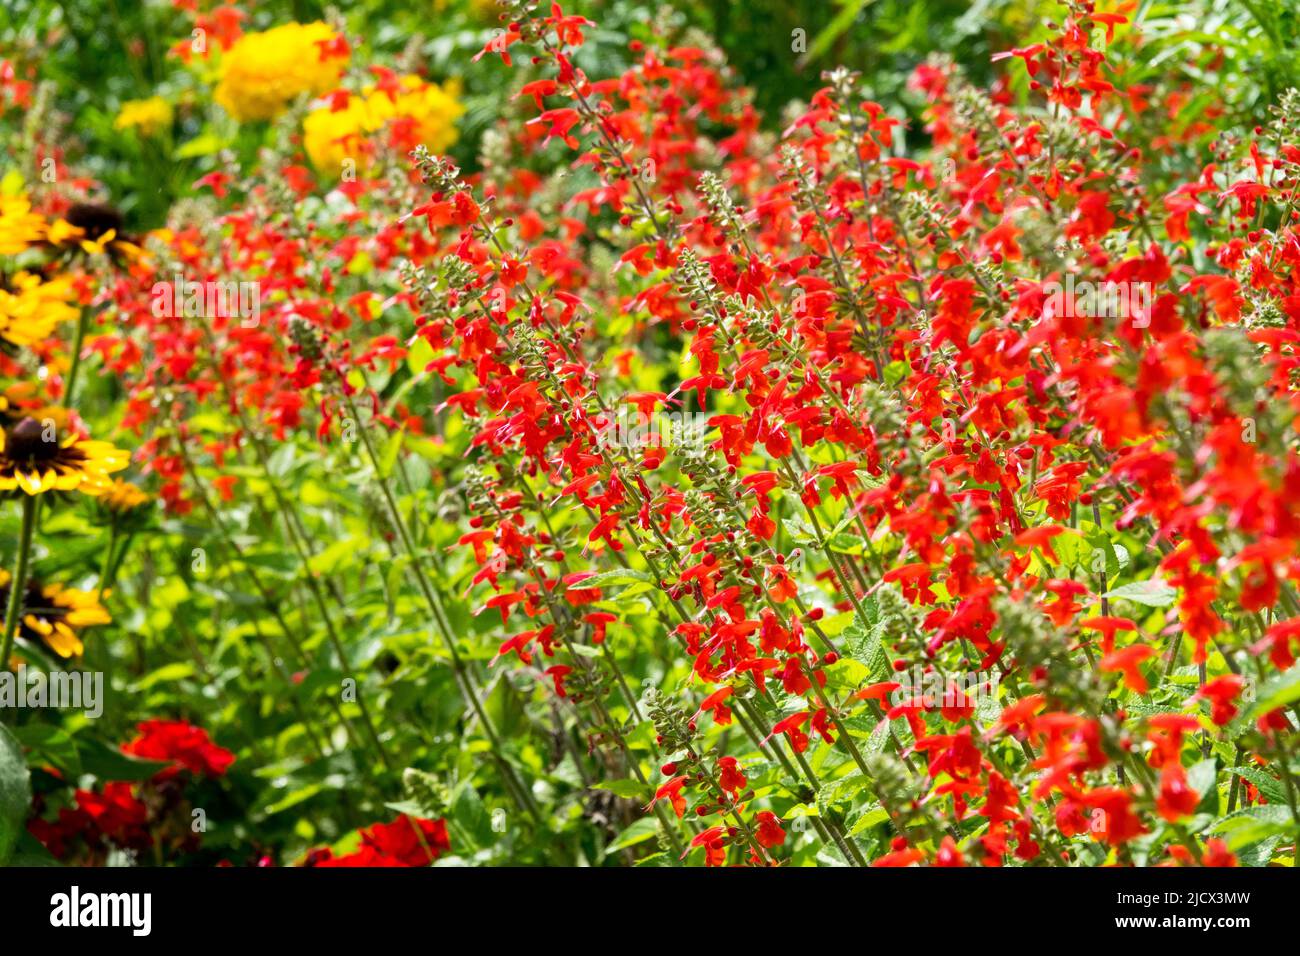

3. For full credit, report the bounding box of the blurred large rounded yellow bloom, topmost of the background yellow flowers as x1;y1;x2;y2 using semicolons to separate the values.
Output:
216;22;343;122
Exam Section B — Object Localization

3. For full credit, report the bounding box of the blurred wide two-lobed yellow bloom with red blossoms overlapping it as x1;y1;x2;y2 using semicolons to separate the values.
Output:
303;75;465;176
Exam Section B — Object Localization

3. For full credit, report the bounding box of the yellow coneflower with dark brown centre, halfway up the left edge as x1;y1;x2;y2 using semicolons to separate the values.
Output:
0;416;130;496
